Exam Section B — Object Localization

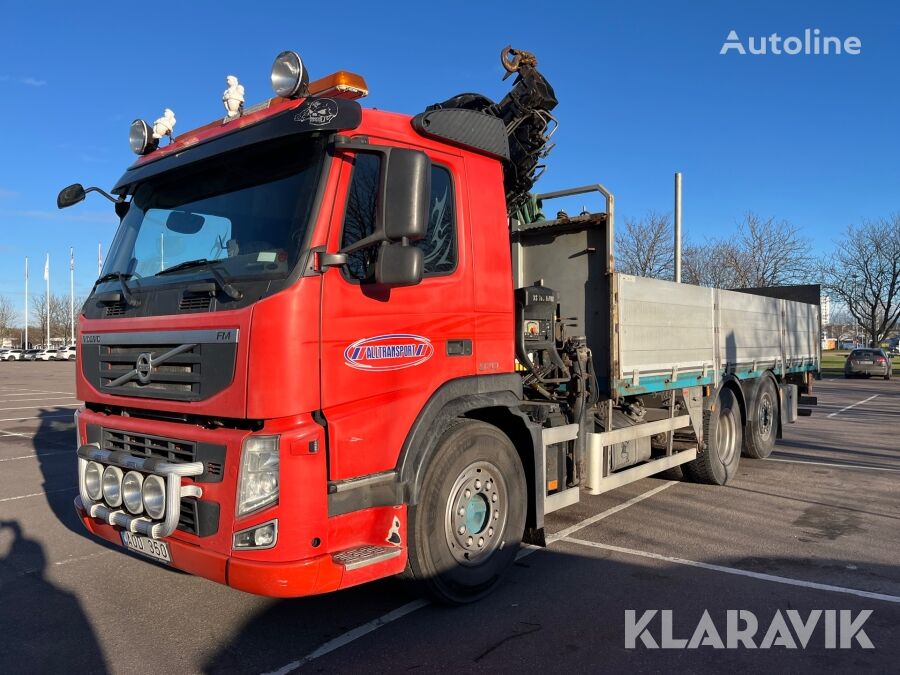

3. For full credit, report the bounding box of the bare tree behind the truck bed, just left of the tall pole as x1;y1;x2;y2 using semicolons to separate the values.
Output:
616;211;675;279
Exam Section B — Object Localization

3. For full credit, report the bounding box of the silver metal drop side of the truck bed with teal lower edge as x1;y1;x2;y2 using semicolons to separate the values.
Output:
612;274;819;395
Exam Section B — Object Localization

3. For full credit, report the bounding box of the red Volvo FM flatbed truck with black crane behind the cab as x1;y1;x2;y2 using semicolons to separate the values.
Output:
58;48;819;603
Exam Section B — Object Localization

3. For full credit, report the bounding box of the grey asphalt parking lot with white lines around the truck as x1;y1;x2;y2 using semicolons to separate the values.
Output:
0;362;900;674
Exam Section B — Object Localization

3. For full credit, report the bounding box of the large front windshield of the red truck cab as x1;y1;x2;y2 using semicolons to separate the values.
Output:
101;135;326;288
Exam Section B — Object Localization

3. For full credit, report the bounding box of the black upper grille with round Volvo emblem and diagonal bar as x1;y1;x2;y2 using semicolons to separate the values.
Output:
82;329;237;401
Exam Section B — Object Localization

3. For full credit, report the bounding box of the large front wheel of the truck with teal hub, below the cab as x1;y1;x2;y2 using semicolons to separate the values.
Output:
405;420;527;605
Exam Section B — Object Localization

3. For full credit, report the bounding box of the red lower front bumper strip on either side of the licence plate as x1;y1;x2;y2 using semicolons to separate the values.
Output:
75;496;344;598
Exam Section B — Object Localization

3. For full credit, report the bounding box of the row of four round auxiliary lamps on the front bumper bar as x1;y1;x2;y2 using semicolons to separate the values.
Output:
84;462;166;520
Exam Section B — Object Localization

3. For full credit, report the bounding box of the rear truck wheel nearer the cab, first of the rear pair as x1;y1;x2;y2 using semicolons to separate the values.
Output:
682;388;742;485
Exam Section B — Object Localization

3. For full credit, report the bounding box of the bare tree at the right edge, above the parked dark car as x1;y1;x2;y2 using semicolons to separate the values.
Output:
820;218;900;346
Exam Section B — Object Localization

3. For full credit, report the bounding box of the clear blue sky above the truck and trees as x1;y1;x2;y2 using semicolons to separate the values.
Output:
0;0;900;318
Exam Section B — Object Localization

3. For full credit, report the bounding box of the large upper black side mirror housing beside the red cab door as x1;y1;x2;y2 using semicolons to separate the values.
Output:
381;148;431;241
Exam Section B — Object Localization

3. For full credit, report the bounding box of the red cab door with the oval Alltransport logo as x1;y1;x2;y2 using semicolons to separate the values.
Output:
321;138;475;480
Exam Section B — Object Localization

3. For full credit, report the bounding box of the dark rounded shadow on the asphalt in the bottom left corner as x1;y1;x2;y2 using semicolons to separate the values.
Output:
0;520;108;673
